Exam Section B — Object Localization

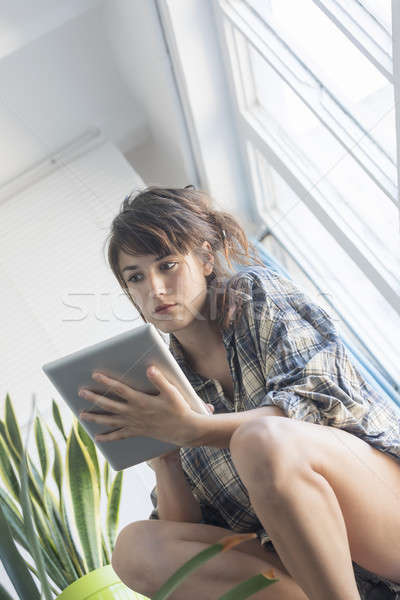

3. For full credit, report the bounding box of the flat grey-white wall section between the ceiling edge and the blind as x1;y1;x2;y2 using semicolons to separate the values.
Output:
0;1;148;188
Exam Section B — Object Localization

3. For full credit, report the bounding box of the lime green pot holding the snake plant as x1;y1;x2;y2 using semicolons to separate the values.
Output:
57;565;149;600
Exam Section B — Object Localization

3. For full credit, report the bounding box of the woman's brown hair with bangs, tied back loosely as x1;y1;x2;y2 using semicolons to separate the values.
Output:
106;185;265;329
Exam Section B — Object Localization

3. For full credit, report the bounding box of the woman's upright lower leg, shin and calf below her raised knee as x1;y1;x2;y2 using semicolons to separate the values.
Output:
236;463;360;600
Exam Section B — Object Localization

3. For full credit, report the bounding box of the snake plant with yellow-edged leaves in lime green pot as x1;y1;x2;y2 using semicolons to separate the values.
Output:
0;394;279;600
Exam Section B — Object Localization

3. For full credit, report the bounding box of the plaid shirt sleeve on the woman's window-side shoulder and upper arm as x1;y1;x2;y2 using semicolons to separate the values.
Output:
241;270;369;430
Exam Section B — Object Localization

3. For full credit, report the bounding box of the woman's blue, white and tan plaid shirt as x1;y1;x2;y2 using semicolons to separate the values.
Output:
149;265;400;591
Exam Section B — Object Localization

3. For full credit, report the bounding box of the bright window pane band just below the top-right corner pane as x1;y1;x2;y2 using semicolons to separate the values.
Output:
264;0;396;162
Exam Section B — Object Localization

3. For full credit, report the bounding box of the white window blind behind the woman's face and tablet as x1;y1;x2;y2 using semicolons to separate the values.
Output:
0;142;147;419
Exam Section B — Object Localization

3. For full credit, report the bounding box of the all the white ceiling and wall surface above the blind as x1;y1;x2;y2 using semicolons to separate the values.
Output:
0;0;192;187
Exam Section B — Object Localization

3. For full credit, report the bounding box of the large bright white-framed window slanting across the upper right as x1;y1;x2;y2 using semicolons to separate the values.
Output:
217;0;400;389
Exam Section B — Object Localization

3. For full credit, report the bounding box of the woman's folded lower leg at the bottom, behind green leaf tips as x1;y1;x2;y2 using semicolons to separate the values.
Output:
113;521;308;600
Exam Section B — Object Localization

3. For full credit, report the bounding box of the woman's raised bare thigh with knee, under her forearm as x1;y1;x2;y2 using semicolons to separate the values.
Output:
249;417;400;582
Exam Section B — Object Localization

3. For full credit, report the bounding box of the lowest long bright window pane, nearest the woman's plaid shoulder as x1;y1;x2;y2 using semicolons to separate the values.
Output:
247;143;400;379
